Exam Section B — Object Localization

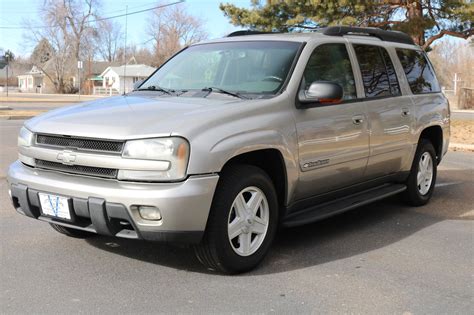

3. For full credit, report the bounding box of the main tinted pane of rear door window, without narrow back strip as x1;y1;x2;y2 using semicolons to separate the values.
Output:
354;45;392;97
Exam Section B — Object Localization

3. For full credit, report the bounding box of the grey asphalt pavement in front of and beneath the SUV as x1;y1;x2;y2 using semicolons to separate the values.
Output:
0;121;474;314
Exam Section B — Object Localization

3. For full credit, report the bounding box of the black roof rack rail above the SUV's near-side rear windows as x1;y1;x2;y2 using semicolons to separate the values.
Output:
323;26;415;45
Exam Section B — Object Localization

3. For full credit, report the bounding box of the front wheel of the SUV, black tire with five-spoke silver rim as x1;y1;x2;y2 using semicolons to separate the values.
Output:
194;165;278;274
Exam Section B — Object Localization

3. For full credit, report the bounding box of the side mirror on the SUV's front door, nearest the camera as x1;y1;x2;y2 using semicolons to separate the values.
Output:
298;81;344;108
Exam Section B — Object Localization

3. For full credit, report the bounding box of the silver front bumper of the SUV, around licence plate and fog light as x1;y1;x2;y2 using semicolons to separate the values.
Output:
8;161;219;243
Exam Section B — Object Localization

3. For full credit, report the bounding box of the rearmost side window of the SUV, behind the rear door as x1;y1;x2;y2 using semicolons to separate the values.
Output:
397;49;440;94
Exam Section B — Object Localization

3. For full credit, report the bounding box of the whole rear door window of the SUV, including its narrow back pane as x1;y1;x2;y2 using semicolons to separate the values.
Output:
354;45;400;98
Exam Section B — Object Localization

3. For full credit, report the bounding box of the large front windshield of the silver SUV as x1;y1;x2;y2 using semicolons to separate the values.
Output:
140;41;301;96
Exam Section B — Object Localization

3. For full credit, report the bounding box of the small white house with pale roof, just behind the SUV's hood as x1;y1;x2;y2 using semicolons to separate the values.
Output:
100;65;156;94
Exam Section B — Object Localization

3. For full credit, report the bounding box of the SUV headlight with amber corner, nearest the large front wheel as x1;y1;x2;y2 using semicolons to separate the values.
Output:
118;137;189;181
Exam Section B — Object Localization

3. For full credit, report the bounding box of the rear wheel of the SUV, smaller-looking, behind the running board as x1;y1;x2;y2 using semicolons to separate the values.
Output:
403;138;438;207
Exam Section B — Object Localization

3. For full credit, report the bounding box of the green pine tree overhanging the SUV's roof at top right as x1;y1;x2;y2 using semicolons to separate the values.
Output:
220;0;474;50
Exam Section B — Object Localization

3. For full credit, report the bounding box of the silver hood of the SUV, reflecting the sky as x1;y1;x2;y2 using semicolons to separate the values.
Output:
26;94;241;140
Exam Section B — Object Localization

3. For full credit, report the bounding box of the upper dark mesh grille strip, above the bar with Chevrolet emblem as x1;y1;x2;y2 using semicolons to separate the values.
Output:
36;135;124;153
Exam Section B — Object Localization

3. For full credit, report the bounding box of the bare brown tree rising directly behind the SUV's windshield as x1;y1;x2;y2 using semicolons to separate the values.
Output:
147;5;208;65
